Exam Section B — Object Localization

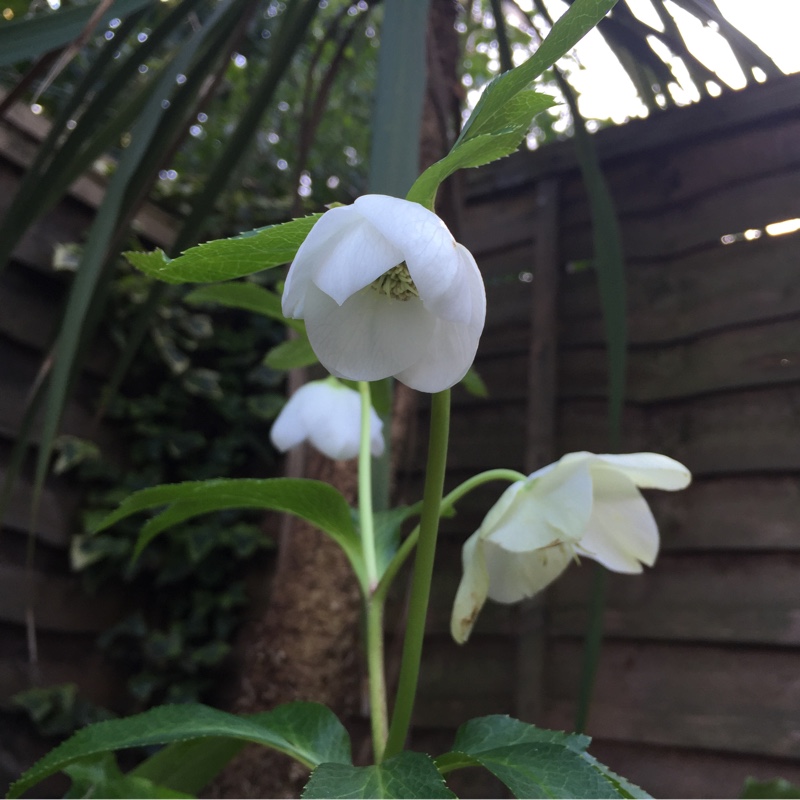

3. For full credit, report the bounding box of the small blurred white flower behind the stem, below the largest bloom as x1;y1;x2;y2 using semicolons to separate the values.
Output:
270;378;384;460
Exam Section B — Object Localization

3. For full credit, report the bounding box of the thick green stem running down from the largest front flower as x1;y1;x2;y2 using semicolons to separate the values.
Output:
384;389;450;758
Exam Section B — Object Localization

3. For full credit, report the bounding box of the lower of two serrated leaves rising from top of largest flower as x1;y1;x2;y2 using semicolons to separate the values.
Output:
407;90;555;208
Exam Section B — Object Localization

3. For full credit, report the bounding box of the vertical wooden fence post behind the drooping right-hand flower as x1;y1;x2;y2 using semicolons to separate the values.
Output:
516;178;559;722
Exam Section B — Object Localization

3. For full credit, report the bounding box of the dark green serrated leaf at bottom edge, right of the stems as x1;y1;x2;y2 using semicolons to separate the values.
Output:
436;715;650;798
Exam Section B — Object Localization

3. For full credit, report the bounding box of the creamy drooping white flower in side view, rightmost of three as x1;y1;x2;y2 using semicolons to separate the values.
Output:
450;452;691;643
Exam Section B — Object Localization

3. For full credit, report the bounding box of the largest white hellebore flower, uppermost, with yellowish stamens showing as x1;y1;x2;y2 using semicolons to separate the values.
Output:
283;194;486;392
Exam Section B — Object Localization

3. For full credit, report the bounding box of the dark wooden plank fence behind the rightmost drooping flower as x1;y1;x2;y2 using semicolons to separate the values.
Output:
412;76;800;797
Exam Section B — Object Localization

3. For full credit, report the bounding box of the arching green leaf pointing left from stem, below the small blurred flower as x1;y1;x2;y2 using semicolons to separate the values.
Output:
92;478;366;585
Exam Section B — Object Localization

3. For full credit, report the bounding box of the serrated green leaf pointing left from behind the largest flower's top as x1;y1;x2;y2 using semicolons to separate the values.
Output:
123;214;322;284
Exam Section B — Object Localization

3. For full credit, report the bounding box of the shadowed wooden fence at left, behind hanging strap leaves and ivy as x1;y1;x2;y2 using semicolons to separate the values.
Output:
0;100;172;782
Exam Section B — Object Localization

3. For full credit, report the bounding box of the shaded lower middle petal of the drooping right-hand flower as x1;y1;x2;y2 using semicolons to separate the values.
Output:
483;540;572;603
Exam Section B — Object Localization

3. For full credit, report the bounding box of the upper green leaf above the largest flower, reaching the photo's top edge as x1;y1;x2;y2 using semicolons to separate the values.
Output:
456;0;617;147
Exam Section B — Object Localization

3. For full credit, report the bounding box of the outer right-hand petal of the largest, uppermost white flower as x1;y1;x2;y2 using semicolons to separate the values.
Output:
395;247;486;392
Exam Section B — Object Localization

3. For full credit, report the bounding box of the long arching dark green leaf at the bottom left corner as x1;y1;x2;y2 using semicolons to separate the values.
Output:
8;703;351;797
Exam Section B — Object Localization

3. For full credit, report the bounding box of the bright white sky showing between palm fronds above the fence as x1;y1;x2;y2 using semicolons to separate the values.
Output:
520;0;800;122
